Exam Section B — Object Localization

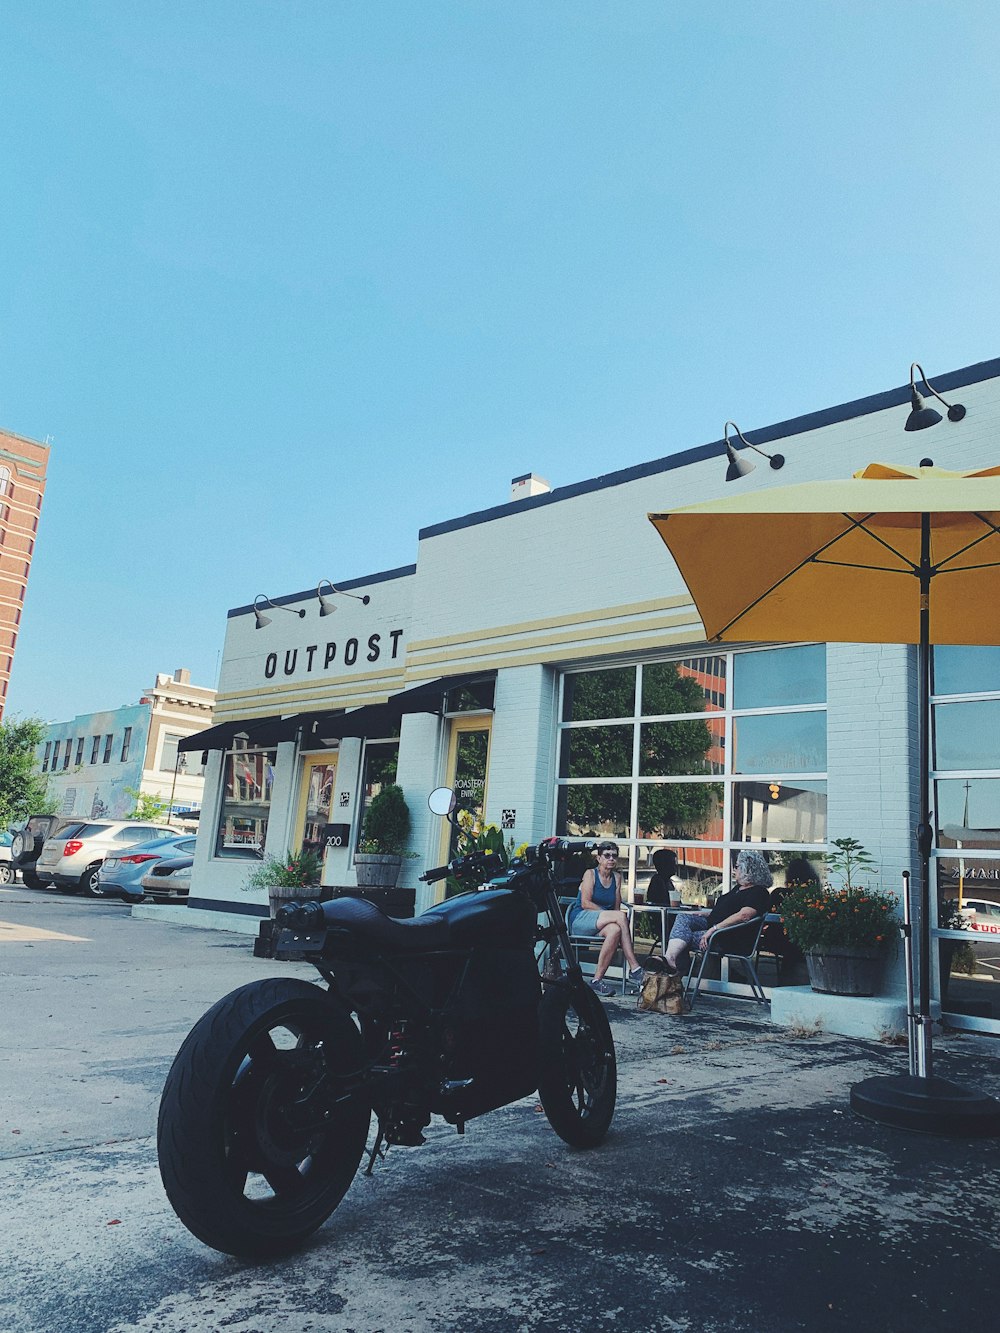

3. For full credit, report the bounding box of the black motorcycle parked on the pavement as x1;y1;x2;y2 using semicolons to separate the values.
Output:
157;789;617;1258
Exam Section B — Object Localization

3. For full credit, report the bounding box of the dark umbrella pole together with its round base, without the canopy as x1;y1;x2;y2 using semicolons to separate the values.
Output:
851;515;1000;1138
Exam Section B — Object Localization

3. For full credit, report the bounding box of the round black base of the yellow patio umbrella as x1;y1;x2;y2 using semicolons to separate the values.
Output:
851;1074;1000;1138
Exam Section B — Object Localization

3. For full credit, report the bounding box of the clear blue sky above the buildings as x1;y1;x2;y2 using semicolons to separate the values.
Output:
0;0;1000;718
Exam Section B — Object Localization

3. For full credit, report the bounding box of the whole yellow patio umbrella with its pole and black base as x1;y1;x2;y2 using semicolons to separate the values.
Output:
649;463;1000;1134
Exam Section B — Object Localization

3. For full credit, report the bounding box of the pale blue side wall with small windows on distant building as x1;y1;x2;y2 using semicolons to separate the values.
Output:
44;704;151;820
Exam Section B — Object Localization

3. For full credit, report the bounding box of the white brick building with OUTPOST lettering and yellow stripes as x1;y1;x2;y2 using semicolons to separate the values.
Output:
172;361;1000;1028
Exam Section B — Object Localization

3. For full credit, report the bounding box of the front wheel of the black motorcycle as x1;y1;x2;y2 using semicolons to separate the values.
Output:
539;985;617;1148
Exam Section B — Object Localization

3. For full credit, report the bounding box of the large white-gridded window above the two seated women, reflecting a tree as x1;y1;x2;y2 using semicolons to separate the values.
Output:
556;644;827;901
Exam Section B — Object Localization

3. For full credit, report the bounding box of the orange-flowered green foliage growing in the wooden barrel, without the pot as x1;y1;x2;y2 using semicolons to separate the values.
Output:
781;837;896;952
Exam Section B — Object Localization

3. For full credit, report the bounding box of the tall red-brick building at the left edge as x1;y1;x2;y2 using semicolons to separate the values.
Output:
0;431;49;718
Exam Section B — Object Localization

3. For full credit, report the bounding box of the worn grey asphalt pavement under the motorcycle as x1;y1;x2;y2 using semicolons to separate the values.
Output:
0;885;1000;1333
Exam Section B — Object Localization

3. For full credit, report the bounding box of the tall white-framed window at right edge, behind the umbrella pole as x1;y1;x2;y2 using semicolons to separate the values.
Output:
931;645;1000;1030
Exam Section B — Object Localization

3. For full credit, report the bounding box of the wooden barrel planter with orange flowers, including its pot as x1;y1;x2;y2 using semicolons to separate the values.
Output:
781;837;896;996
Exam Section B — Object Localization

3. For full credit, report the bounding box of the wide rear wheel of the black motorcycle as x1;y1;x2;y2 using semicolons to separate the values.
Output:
156;977;371;1258
